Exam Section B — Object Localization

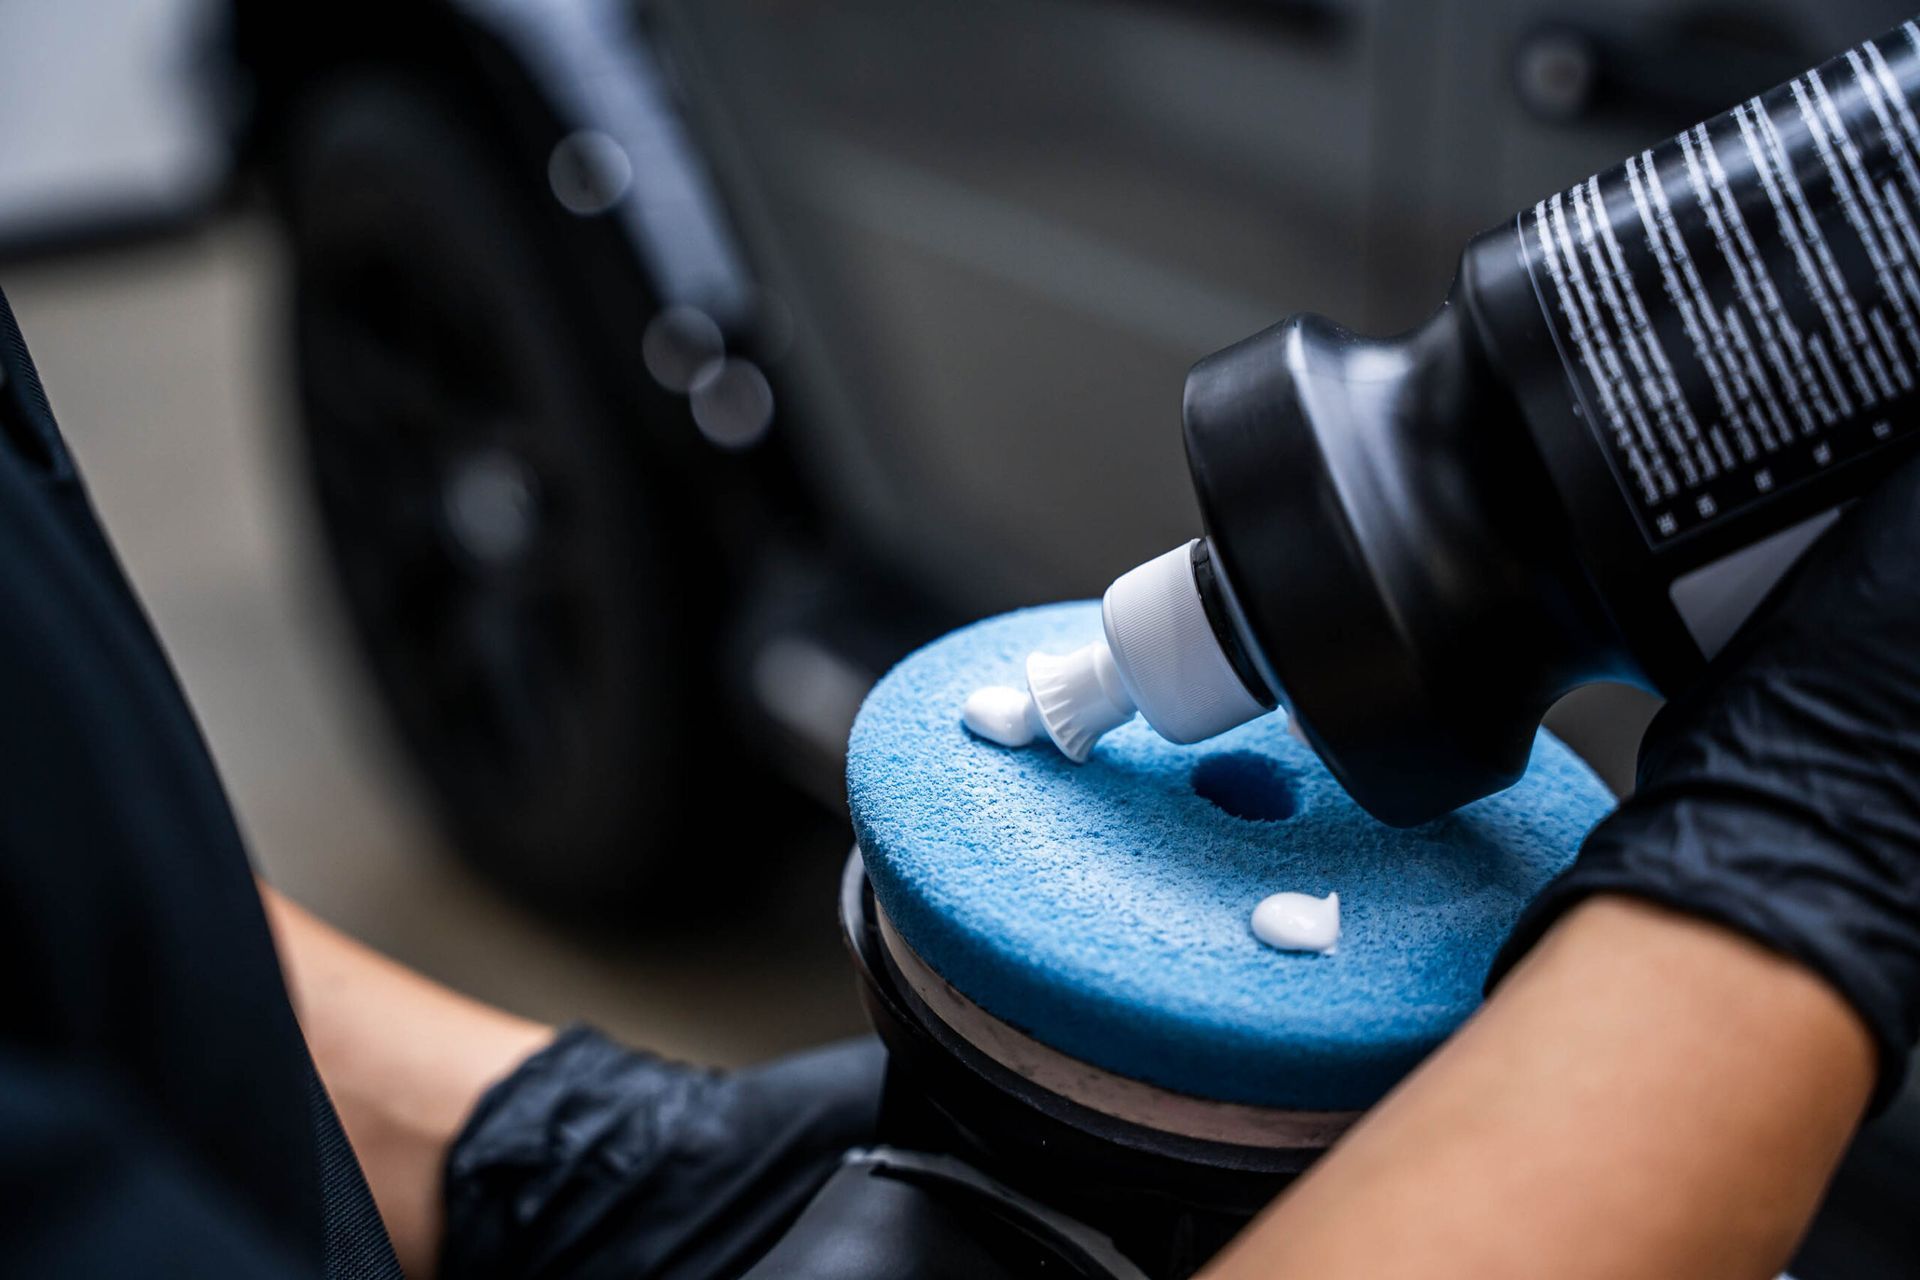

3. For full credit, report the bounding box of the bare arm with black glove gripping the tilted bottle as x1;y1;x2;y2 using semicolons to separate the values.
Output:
1221;454;1920;1280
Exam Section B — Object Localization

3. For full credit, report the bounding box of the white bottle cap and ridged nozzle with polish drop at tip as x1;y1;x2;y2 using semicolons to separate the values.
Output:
962;541;1269;764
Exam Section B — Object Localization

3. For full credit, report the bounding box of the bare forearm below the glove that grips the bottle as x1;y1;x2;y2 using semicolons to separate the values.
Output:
1208;898;1874;1280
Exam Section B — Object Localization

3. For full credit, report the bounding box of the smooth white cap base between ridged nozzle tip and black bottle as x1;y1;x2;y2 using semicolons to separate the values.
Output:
1100;543;1267;743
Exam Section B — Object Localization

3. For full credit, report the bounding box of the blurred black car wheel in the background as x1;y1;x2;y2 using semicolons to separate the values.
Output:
282;77;780;919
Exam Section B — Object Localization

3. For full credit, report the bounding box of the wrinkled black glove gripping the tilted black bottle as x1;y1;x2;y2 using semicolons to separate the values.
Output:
1488;461;1920;1109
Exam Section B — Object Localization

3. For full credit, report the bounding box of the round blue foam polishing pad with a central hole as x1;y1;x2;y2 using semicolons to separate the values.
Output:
847;603;1613;1111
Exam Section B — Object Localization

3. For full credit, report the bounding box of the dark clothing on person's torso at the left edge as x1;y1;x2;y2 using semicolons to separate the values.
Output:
0;289;399;1280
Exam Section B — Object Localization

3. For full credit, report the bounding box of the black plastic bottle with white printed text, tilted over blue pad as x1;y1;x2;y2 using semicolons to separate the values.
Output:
1082;23;1920;825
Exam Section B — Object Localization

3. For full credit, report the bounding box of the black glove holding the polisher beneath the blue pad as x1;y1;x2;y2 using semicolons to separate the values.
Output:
440;1027;885;1280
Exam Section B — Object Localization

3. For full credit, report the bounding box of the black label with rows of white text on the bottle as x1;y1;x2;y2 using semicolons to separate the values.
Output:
1519;23;1920;545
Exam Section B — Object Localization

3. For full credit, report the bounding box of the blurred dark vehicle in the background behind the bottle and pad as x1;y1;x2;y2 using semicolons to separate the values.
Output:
214;0;1901;875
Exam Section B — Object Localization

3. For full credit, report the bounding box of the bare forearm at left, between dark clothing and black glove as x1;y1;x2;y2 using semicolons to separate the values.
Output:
261;887;553;1280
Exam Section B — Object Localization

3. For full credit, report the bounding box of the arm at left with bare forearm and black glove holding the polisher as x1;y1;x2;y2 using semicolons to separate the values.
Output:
261;887;883;1280
